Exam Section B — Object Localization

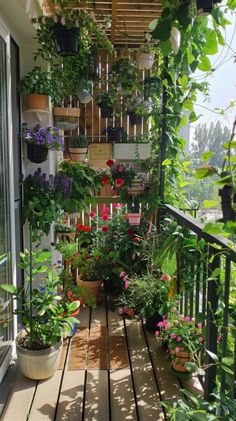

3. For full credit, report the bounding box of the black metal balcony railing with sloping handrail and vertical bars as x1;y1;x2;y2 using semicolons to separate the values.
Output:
165;205;236;400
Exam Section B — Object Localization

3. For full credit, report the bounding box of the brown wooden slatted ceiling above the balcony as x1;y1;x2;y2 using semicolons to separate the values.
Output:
43;0;161;46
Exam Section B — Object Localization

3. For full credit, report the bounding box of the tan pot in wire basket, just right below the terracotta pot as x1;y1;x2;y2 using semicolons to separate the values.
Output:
53;107;80;130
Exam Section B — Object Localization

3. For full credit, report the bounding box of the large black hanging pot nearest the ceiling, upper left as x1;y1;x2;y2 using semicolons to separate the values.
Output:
52;23;79;56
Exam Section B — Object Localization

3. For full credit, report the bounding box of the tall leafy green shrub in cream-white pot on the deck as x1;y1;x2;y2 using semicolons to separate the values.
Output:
1;243;80;380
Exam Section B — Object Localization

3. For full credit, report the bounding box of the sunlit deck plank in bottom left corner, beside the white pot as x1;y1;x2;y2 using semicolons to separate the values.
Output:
1;372;37;421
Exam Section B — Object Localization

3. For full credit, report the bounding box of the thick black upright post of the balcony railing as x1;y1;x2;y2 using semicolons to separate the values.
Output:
204;247;220;400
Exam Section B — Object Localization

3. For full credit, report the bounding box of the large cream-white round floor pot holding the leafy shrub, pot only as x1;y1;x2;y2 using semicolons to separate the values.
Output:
16;332;62;380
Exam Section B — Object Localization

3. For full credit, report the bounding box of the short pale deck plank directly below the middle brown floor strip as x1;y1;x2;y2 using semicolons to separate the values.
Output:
84;370;109;421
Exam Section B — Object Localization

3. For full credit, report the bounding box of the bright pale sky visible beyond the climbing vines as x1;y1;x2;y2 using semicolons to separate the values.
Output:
190;8;236;144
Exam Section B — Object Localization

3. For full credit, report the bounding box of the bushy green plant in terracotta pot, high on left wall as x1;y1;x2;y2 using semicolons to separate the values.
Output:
18;66;53;111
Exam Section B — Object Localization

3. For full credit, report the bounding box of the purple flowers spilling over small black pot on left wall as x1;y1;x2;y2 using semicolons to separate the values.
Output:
22;124;63;150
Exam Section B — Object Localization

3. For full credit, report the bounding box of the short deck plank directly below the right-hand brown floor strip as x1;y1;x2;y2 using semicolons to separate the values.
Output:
110;369;137;421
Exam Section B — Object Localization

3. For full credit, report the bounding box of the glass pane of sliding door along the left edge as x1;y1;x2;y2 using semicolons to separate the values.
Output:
0;36;13;370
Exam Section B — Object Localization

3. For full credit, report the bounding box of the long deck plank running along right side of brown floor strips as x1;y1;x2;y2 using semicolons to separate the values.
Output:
126;320;165;421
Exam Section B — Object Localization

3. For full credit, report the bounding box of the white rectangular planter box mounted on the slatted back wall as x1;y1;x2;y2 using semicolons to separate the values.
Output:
114;143;151;161
